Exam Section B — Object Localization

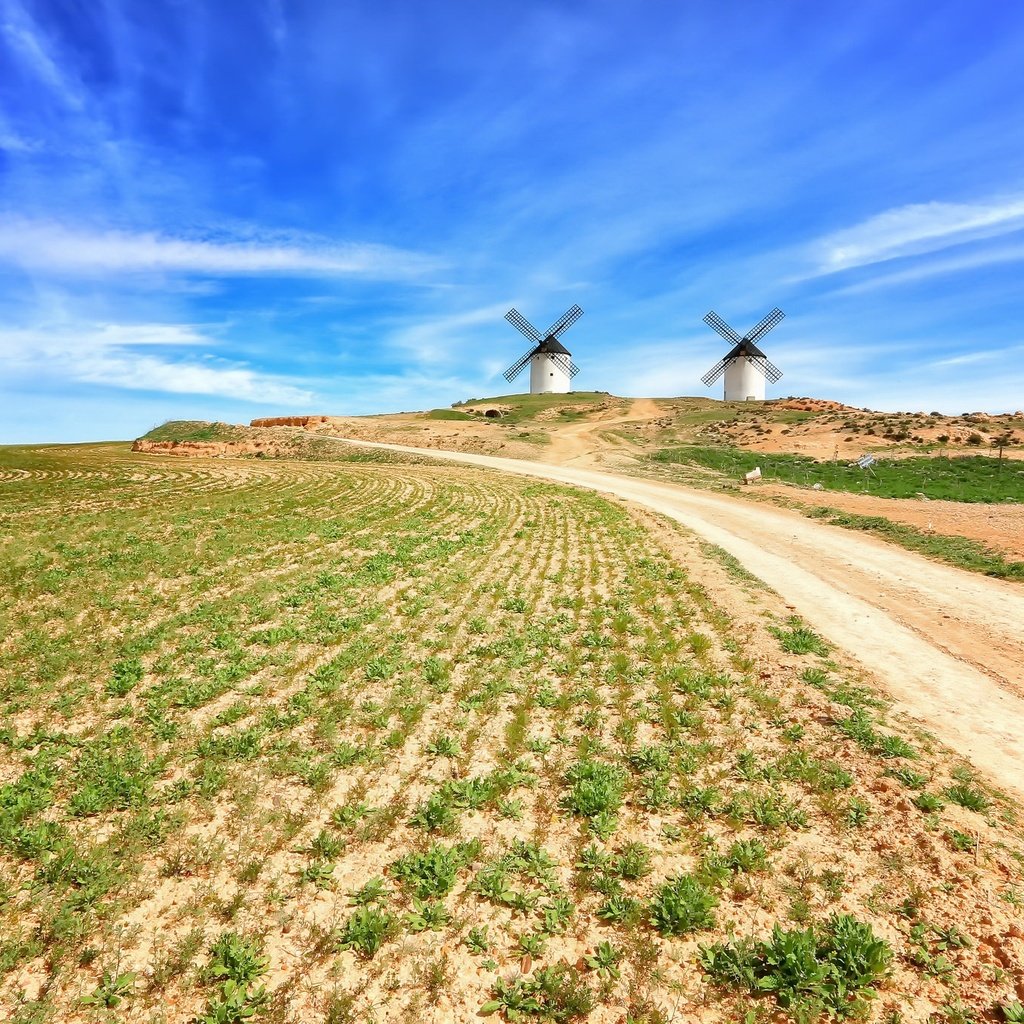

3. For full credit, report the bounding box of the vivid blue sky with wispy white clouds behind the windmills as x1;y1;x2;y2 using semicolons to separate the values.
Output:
0;0;1024;442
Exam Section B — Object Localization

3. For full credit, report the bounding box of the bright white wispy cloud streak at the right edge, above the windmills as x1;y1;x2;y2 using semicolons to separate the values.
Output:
809;196;1024;276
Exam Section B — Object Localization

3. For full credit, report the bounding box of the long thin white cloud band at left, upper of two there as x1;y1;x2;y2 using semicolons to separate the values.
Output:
0;221;439;279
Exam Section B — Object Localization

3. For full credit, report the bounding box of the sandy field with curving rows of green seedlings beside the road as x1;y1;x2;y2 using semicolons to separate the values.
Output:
0;445;1024;1024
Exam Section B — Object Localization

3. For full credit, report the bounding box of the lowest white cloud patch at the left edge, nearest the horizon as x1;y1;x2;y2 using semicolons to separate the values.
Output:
0;324;314;407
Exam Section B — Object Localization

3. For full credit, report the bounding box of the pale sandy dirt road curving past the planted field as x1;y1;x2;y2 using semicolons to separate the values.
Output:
325;437;1024;796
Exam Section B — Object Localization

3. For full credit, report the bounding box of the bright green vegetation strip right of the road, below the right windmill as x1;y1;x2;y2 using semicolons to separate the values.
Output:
651;445;1024;502
